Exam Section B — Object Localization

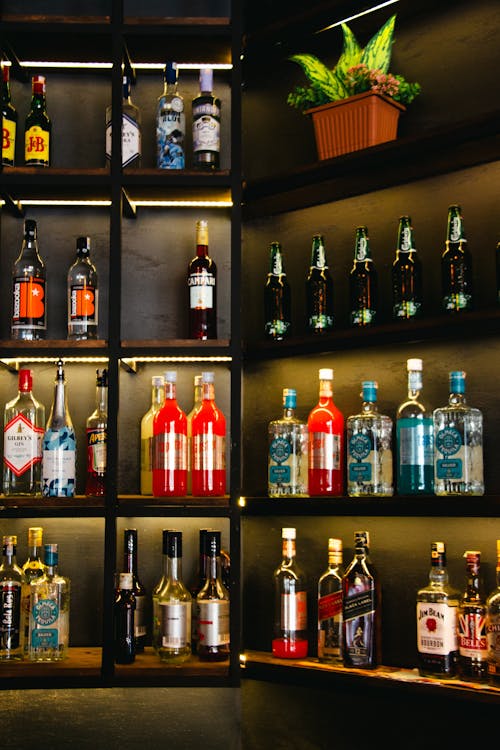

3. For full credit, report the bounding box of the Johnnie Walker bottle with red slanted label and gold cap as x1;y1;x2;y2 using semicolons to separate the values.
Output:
318;539;344;664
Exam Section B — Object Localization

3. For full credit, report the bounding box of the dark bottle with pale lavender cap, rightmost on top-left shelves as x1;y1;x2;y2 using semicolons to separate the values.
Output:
192;68;221;169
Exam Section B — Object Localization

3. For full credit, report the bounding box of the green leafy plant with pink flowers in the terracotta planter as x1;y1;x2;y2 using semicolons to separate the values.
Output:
287;15;420;110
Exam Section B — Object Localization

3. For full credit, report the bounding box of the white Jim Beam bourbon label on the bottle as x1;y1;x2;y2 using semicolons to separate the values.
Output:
417;602;458;656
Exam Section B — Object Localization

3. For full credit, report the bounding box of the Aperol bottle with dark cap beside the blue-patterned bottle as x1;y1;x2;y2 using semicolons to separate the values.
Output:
85;368;108;497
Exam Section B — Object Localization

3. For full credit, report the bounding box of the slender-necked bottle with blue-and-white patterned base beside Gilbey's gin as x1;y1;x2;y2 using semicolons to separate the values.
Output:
42;359;76;497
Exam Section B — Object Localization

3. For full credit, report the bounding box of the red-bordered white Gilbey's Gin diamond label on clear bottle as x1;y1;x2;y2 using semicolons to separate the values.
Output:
3;414;44;477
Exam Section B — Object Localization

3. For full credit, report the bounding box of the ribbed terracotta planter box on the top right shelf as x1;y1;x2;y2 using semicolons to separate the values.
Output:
305;91;405;159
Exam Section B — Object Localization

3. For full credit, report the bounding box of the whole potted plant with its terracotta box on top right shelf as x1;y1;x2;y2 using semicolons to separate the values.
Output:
287;15;420;159
